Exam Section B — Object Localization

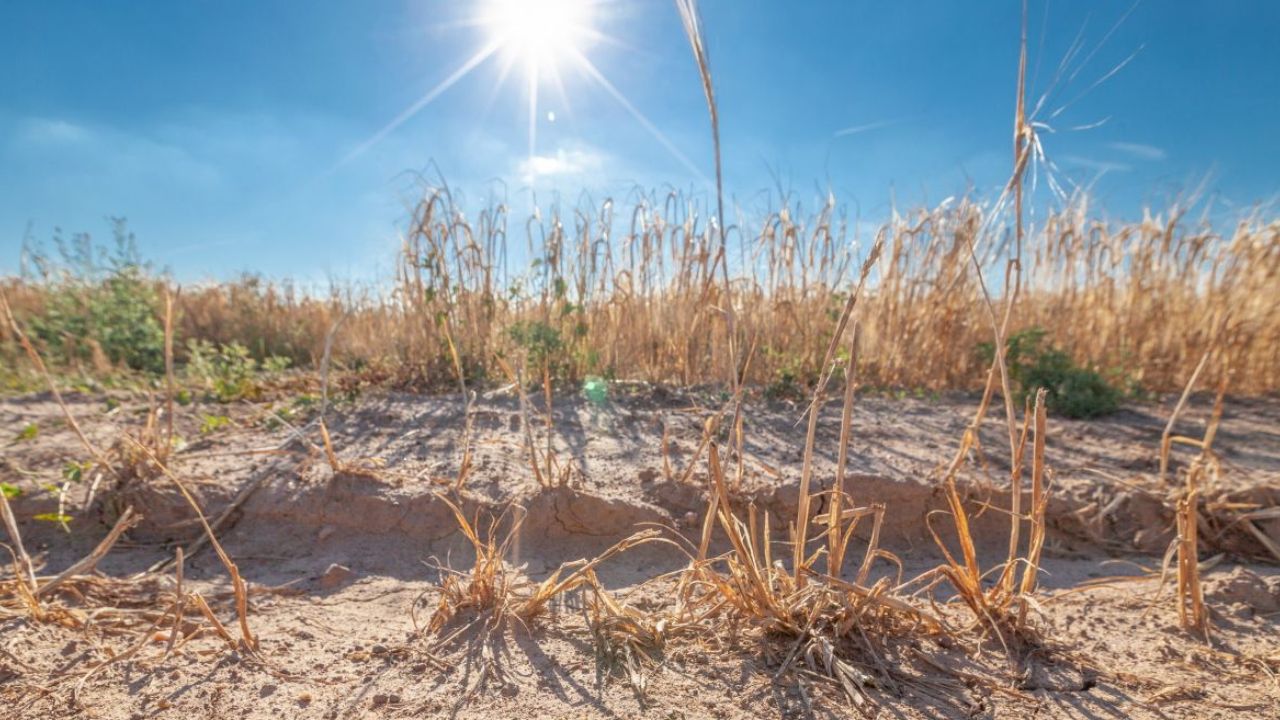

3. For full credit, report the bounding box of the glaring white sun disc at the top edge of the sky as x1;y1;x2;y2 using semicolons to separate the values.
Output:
481;0;594;73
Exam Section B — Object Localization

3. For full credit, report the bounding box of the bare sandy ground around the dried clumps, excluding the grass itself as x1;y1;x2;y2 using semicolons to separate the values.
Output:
0;387;1280;720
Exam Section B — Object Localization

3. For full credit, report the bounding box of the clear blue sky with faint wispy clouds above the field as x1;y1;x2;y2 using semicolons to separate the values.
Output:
0;0;1280;282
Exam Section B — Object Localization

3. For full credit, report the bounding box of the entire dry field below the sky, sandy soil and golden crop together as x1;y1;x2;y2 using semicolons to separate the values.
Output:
0;0;1280;720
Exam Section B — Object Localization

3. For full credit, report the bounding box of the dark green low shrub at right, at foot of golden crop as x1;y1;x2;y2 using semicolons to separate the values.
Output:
978;328;1123;419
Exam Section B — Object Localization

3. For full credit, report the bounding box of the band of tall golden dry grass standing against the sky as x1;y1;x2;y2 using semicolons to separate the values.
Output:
0;188;1280;393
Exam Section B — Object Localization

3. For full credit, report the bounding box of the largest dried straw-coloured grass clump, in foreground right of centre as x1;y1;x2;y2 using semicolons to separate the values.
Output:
680;445;947;705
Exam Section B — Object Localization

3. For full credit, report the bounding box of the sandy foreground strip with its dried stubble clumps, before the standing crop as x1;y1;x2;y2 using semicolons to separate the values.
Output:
0;371;1280;719
